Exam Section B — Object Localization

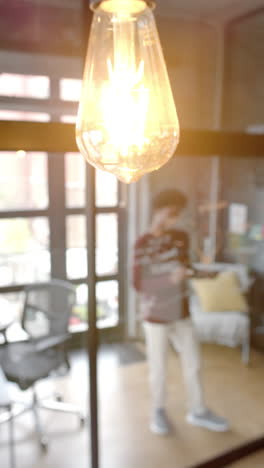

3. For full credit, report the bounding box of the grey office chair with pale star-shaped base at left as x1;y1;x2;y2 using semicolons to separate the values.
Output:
0;279;85;451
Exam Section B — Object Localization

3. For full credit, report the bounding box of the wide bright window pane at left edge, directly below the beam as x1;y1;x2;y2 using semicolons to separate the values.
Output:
0;150;48;211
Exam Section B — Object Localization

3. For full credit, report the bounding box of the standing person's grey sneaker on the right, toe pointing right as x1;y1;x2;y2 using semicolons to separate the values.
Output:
186;409;229;432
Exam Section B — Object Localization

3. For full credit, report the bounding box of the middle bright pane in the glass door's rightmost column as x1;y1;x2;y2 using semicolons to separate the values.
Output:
96;214;118;275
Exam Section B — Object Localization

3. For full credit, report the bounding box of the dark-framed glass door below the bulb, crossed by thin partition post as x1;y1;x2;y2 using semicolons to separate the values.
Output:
65;153;124;342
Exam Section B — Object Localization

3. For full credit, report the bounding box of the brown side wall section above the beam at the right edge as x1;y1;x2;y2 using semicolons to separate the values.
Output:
224;11;264;130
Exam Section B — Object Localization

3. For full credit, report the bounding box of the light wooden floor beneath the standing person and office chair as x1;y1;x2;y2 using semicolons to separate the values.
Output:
0;346;264;468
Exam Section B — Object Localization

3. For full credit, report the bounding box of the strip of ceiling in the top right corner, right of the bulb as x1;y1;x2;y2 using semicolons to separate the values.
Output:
156;0;264;22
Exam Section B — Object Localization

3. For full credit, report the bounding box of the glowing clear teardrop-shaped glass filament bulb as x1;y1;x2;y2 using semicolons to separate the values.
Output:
76;0;179;183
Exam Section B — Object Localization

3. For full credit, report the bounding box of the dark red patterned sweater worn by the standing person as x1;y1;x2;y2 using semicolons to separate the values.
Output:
133;230;189;323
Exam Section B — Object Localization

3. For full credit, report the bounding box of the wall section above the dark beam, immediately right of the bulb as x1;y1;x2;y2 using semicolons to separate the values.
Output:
157;18;216;128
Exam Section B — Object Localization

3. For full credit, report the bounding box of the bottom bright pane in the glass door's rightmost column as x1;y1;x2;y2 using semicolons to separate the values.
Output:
96;281;118;328
